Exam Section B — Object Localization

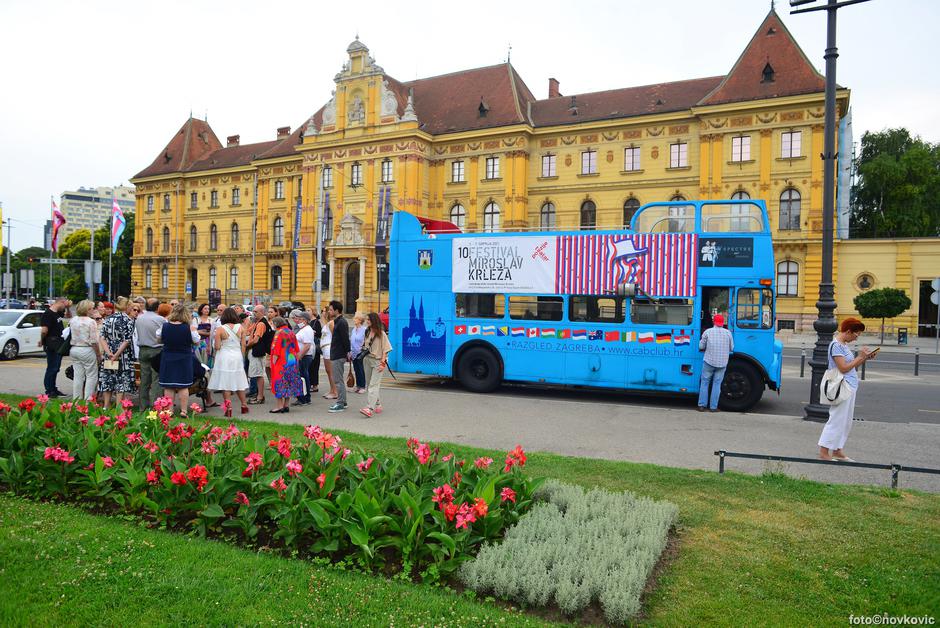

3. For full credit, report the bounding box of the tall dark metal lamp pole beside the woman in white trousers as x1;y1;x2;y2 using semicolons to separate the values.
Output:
790;0;868;422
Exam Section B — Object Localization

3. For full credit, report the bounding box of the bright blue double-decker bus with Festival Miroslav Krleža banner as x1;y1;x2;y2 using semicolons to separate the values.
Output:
389;200;783;411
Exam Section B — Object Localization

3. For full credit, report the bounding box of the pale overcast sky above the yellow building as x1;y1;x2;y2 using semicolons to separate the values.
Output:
0;0;940;251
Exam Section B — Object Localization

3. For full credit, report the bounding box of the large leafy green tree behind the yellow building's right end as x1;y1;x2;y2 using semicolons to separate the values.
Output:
852;128;940;238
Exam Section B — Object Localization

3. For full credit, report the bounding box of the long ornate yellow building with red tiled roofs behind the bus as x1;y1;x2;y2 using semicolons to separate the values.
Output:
132;10;938;330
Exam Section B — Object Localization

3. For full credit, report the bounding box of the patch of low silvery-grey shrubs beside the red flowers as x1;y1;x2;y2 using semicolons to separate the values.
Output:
459;480;678;623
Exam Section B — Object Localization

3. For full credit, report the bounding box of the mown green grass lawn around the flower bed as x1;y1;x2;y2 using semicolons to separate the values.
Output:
0;398;940;626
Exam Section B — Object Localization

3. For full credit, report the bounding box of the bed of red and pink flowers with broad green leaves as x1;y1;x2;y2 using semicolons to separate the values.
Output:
0;396;540;581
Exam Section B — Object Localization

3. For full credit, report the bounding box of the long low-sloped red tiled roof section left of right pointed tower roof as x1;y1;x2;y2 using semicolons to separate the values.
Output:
532;76;724;127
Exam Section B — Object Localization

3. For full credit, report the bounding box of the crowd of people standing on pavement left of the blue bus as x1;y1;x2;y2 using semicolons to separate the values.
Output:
39;297;392;417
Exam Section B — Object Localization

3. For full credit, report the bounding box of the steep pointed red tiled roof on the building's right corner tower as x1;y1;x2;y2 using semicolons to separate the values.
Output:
699;9;826;105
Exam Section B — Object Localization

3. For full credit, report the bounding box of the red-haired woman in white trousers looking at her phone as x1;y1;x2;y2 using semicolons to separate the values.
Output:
819;318;874;462
